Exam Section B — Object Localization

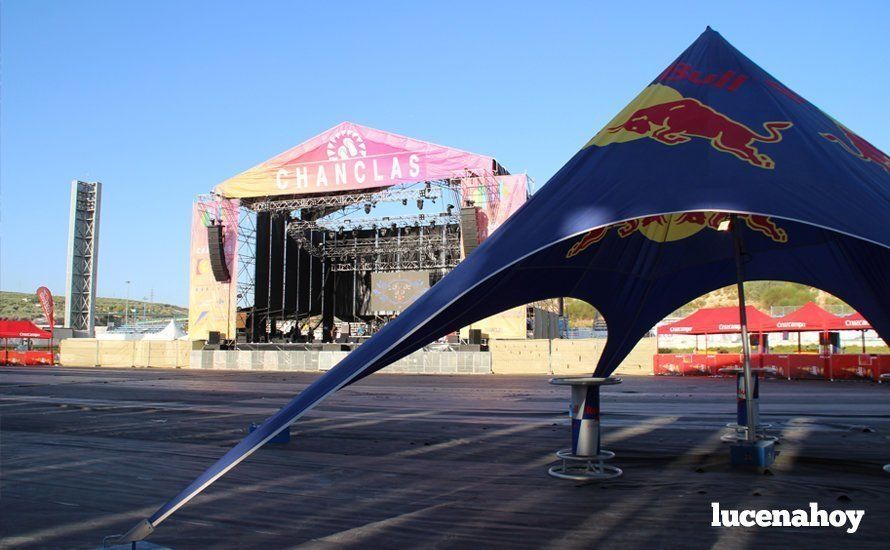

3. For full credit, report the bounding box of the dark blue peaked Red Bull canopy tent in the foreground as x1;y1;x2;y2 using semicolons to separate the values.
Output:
124;28;890;541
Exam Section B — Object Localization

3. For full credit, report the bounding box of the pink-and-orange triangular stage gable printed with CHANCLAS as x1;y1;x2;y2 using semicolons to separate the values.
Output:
214;122;496;198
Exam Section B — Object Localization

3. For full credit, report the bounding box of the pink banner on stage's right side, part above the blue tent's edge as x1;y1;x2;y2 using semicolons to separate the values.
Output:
461;174;528;243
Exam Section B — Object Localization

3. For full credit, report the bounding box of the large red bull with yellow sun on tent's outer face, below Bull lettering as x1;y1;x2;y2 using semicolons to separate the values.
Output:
587;84;792;170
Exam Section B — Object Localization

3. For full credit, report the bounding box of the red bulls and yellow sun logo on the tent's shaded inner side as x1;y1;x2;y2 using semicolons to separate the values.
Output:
566;212;788;258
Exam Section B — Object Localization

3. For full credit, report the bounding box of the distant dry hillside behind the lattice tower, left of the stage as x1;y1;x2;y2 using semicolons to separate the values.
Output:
0;291;188;325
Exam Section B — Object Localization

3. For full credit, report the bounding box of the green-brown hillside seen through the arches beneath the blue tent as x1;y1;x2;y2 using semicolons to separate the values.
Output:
566;281;847;326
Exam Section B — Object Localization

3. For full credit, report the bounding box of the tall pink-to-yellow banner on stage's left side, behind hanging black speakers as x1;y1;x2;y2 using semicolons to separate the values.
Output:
189;197;238;340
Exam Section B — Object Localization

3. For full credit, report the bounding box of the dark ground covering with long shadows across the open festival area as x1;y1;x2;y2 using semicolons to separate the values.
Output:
0;368;890;549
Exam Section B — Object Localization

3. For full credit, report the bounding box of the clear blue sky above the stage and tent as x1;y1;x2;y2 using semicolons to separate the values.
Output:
0;0;890;305
